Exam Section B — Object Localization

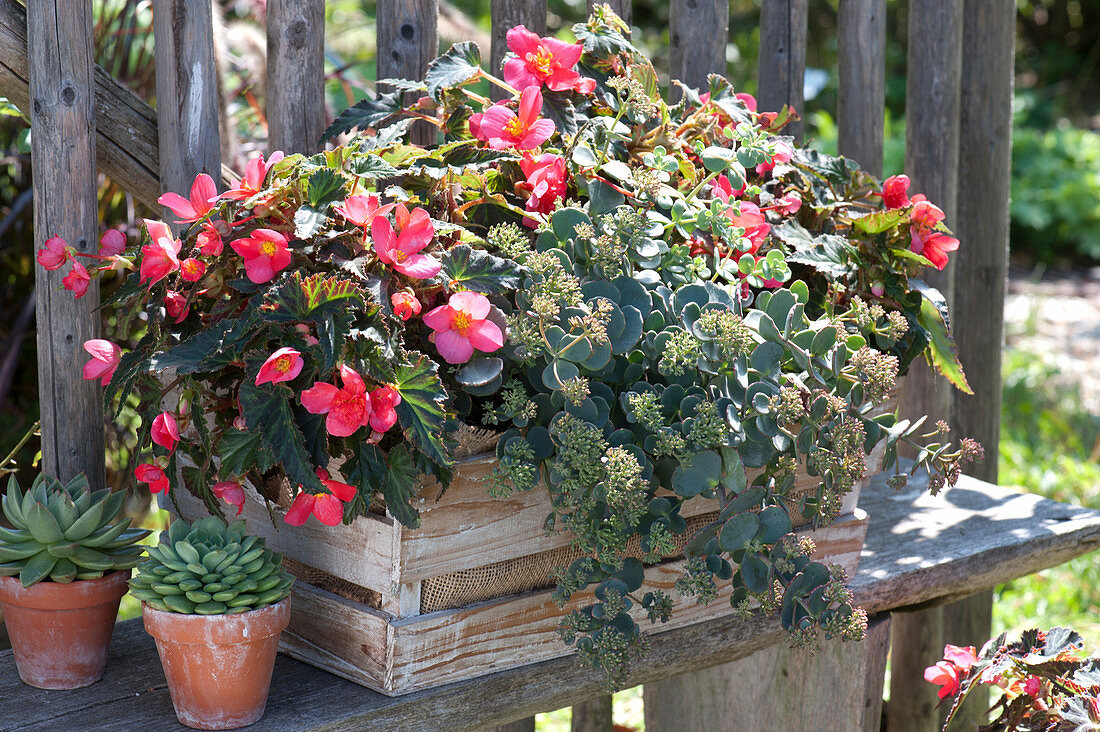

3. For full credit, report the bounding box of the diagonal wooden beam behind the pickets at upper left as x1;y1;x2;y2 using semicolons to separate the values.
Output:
0;0;239;211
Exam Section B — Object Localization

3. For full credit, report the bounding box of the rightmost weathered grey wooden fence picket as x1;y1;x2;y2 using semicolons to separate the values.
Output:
944;0;1015;729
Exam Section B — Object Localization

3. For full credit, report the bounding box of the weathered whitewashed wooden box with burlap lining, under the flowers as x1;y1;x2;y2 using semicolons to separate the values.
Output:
177;456;867;696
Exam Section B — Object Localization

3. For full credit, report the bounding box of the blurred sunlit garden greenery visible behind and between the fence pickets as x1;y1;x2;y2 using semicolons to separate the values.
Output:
0;0;1100;729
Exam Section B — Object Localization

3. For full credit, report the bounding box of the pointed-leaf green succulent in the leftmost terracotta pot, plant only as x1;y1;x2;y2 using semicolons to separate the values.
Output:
0;473;149;587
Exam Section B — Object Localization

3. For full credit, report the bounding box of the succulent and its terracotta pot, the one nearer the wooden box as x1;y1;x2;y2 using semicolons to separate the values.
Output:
130;516;294;730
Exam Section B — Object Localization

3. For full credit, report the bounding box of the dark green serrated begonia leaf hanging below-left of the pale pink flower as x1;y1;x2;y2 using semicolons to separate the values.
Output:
394;352;450;468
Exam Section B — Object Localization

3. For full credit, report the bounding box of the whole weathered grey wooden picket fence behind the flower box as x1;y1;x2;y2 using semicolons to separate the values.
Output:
0;0;1014;732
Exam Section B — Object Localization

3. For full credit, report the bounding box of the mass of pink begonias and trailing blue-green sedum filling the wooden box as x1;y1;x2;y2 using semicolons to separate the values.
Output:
40;9;980;680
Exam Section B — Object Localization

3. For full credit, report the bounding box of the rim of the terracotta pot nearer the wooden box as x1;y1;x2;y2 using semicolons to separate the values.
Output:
141;594;290;645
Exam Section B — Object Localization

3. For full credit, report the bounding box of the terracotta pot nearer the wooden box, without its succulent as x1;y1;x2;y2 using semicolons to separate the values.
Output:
142;597;290;730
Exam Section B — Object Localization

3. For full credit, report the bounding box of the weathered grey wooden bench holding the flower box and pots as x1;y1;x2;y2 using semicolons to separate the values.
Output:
0;468;1100;732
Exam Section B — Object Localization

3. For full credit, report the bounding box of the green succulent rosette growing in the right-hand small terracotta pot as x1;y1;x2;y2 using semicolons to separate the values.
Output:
130;516;294;615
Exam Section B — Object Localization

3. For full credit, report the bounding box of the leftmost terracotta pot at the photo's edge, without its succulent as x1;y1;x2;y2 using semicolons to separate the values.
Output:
0;569;130;689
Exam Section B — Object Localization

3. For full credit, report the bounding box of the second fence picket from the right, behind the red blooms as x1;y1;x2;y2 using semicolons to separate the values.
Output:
888;0;963;732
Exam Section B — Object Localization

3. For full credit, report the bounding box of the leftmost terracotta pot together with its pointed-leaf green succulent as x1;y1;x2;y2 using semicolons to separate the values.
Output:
0;473;149;689
